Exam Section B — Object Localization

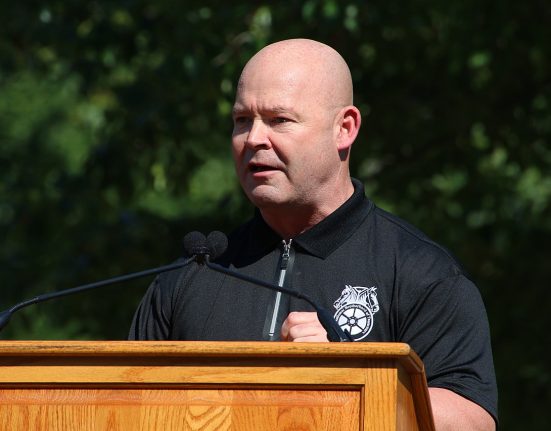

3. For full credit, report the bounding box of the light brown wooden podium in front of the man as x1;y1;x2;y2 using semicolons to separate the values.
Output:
0;341;434;431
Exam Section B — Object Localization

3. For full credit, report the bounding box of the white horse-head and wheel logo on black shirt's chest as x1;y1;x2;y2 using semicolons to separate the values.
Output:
333;284;379;341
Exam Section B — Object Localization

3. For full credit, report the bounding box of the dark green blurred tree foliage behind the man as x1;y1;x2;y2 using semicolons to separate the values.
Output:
0;0;551;431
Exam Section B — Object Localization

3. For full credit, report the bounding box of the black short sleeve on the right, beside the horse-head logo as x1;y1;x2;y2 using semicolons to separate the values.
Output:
400;275;497;419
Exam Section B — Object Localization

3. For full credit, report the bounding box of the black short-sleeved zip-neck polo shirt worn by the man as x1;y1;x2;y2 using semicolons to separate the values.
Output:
129;180;497;418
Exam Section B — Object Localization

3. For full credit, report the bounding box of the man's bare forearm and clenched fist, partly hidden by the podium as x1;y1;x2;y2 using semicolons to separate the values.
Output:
281;311;495;431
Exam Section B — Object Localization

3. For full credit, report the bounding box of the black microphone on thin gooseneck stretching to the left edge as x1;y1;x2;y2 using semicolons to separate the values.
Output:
0;232;209;331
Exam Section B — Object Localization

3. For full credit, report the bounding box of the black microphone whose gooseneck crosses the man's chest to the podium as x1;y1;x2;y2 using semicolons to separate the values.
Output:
192;231;354;341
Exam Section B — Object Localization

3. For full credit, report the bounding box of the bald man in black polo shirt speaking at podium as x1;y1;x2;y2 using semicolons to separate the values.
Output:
130;39;497;430
